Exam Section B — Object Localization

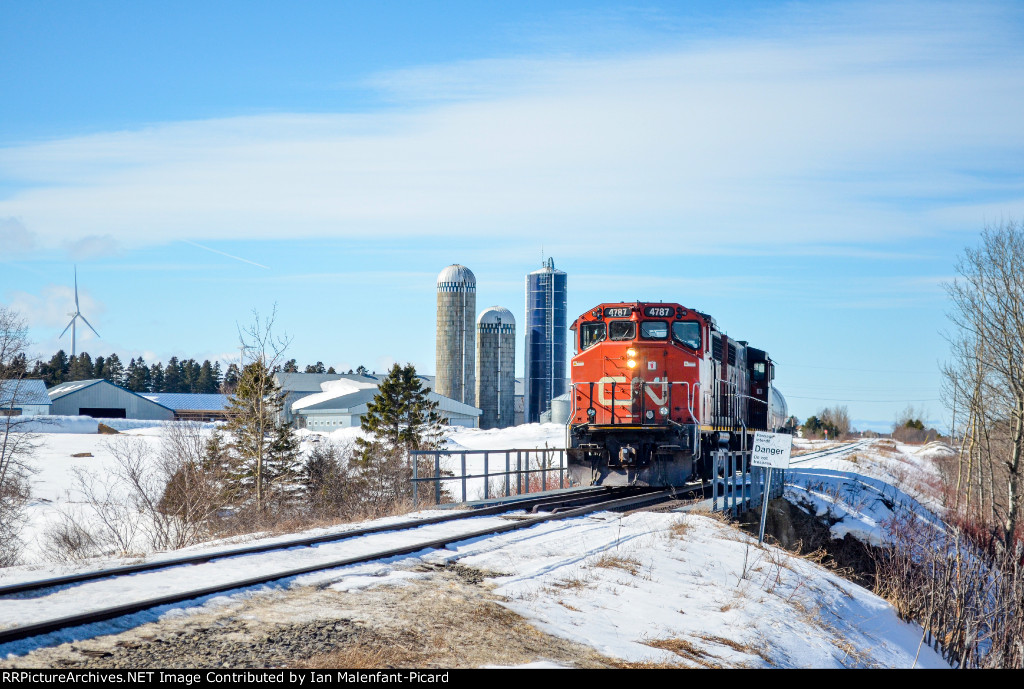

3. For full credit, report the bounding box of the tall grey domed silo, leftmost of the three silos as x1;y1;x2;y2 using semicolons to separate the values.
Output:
434;264;476;405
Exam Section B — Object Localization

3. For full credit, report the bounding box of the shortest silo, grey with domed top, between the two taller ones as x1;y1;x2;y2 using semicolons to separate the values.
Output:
476;306;515;428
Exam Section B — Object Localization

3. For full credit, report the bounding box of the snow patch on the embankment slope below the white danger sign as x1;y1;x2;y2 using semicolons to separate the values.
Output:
444;513;945;668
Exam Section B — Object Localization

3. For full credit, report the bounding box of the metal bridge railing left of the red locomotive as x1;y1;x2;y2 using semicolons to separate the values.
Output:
411;447;569;508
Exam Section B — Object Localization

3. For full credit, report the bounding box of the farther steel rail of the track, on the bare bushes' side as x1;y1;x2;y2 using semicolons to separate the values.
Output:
0;487;610;597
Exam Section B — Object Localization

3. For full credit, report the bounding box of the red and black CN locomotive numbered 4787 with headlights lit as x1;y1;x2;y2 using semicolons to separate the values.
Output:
567;302;786;485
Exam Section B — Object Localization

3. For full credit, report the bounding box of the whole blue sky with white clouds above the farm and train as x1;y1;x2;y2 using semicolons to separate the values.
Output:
0;1;1024;428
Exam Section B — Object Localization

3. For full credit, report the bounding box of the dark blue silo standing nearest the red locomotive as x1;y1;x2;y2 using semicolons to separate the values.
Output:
525;258;568;424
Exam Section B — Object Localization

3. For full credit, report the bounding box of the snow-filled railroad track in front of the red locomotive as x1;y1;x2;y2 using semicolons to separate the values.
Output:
0;488;674;656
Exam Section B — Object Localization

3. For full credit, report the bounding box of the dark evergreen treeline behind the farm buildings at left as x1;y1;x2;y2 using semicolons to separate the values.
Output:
18;349;369;394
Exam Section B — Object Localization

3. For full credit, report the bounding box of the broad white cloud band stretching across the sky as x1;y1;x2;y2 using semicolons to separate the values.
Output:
0;2;1024;255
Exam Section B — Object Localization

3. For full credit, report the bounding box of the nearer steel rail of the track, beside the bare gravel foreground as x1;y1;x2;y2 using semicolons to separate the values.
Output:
0;489;674;645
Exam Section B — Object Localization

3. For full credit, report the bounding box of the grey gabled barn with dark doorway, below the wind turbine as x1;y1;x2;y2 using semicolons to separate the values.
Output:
46;378;174;421
